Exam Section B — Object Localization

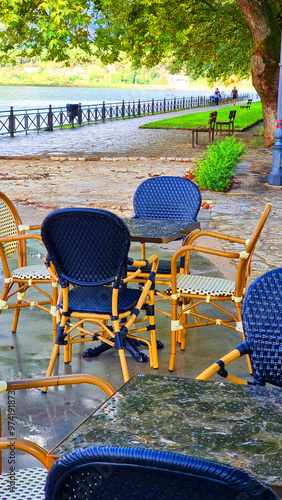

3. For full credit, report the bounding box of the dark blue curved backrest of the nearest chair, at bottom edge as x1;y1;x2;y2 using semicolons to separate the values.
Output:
45;446;278;500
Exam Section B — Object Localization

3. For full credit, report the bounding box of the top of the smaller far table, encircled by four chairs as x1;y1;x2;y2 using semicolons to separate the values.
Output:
123;218;200;243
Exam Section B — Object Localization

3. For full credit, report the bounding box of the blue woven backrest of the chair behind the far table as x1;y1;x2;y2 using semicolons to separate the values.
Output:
133;176;201;221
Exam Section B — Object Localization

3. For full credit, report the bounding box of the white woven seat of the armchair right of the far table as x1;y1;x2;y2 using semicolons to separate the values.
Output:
177;274;235;297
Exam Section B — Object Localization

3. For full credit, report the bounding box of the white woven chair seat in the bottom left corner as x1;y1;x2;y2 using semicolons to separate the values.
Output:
0;467;48;500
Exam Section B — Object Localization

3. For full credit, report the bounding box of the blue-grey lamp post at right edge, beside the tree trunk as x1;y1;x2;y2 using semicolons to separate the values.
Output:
268;18;282;186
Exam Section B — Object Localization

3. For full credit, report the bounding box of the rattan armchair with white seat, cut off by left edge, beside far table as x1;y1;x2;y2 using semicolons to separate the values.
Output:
0;192;57;340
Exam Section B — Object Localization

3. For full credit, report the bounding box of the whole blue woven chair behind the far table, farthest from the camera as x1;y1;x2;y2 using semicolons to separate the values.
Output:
128;176;202;310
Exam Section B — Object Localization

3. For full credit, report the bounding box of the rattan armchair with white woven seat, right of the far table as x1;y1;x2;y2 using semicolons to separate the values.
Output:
169;203;271;371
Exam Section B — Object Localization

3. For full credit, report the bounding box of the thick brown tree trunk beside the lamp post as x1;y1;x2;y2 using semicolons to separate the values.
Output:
237;0;281;146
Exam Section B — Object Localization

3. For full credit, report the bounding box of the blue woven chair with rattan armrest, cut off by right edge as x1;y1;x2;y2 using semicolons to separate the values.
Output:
196;269;282;387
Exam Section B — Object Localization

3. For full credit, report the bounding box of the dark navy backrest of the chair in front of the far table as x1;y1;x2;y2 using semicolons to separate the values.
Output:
41;208;130;286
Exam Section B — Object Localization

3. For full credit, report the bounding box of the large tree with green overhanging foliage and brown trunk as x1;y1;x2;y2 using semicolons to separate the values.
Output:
0;0;281;145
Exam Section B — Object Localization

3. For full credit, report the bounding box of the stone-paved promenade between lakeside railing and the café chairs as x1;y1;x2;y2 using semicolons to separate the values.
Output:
0;102;282;277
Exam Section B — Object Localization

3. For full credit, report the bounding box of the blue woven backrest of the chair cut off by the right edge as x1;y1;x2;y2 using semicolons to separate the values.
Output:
242;269;282;387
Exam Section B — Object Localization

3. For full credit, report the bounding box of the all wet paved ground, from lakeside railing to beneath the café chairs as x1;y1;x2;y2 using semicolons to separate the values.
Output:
0;103;282;482
